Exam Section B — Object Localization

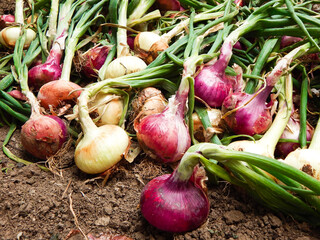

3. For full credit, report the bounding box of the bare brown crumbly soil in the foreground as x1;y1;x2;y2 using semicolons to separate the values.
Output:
0;0;320;240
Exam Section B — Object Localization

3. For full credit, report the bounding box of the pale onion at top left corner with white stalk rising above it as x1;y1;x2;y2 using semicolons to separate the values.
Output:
0;0;37;49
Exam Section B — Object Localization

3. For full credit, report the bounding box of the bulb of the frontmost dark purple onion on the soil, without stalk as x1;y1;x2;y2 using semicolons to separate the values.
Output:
140;172;210;232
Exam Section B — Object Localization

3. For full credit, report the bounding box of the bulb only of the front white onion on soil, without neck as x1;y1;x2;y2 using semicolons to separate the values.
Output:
74;125;130;174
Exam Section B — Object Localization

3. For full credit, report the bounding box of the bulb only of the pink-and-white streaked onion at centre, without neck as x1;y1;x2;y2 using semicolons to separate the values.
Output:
134;108;191;163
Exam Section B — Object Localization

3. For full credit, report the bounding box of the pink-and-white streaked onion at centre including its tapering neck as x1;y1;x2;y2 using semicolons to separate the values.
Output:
134;78;191;163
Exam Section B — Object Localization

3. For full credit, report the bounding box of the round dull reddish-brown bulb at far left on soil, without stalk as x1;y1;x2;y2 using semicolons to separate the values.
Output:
21;115;68;159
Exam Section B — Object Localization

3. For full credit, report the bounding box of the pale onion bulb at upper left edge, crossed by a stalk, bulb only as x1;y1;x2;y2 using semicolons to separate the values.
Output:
0;26;37;48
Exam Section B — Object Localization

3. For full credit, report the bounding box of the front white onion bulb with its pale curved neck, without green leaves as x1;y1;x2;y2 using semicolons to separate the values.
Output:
74;89;130;174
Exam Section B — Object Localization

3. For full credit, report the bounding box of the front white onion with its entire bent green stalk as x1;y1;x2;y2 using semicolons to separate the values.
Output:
74;64;180;174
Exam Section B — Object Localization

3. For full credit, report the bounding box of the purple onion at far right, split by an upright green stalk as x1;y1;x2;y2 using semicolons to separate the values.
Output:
276;117;313;158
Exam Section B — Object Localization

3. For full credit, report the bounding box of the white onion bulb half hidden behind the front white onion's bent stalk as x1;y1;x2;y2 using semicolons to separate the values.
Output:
105;56;147;78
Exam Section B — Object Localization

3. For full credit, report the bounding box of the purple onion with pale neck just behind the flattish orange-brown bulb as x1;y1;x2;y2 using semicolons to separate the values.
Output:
28;44;62;90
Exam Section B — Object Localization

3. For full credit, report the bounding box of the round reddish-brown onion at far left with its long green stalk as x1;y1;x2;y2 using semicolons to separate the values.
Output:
14;32;68;160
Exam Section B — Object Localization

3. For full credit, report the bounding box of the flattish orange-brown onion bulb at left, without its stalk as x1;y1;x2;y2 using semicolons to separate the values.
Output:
37;80;81;109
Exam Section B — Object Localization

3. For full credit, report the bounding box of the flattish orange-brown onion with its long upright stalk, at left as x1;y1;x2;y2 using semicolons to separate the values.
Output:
37;0;107;109
